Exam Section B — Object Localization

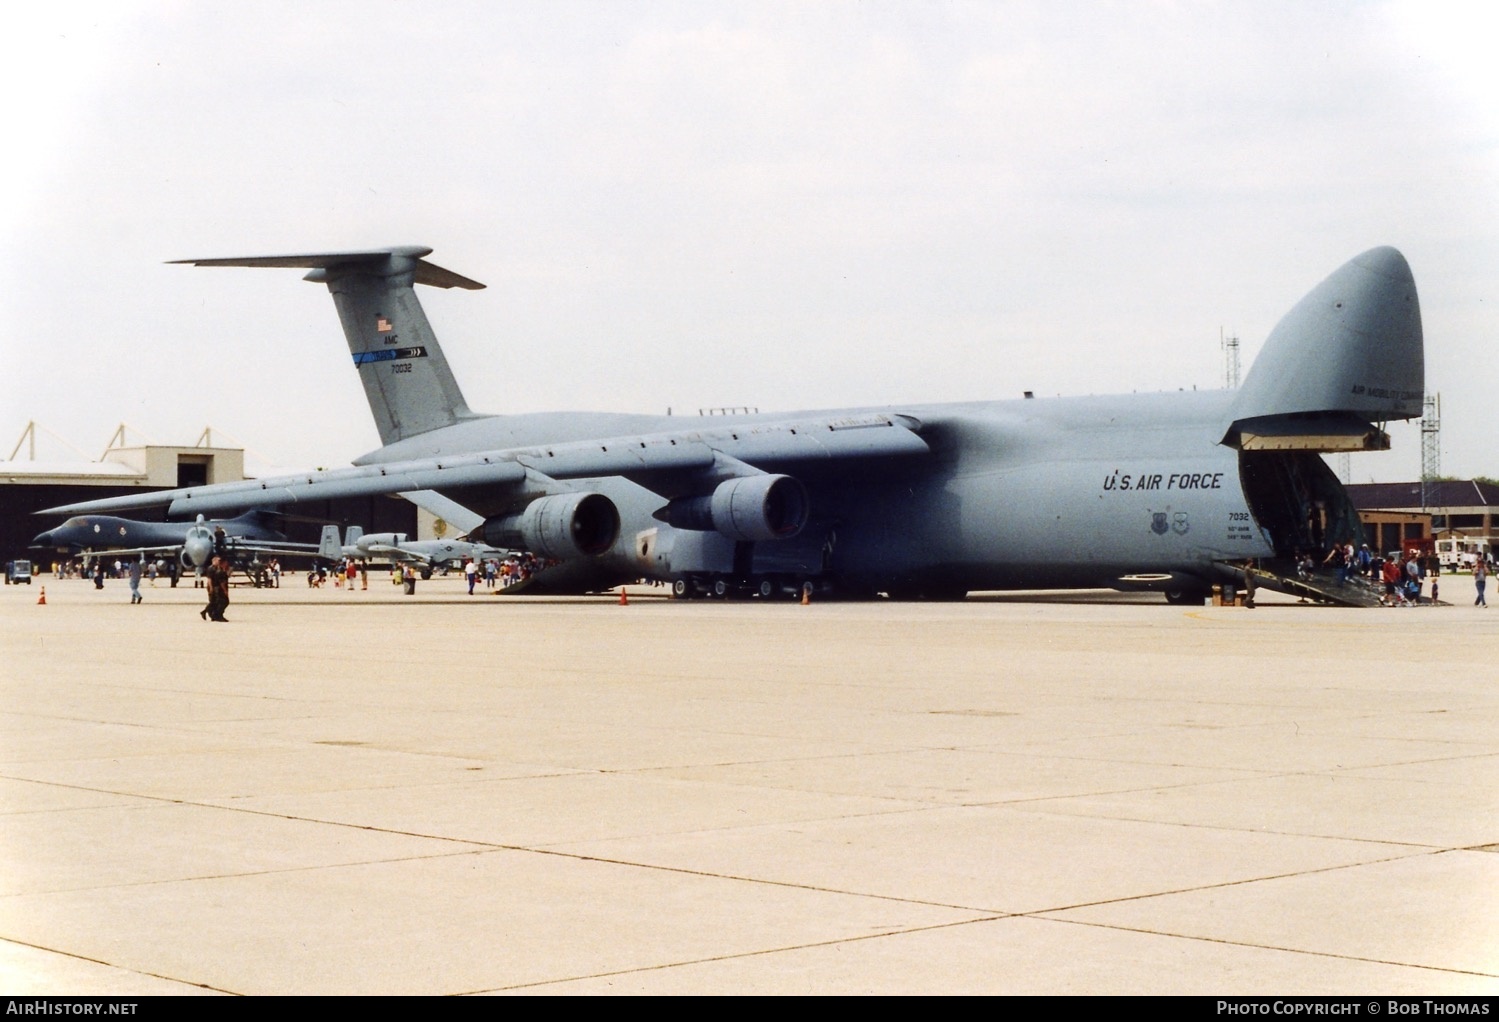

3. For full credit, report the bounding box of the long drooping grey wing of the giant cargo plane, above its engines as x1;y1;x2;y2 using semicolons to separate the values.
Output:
40;412;928;515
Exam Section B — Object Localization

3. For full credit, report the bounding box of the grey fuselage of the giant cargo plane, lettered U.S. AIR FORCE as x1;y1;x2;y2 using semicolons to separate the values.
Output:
357;391;1313;592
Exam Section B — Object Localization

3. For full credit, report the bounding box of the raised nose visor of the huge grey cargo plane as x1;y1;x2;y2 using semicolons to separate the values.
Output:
1225;247;1426;451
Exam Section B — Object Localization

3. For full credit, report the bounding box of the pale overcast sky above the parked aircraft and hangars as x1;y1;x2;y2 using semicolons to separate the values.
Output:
0;0;1499;483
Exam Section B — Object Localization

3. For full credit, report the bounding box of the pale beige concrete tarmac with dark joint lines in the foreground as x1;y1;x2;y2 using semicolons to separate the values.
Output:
0;577;1499;997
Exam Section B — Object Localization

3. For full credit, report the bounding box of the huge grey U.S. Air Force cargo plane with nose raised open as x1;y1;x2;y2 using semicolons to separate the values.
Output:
46;247;1424;602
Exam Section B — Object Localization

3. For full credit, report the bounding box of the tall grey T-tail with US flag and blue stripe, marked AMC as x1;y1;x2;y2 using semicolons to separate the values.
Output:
175;246;484;444
